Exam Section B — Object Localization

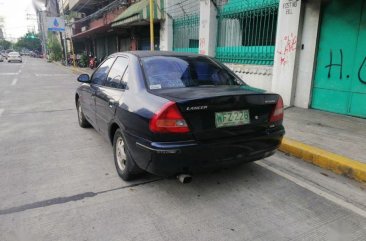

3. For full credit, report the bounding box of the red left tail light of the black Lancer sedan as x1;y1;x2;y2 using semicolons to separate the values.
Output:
149;101;190;133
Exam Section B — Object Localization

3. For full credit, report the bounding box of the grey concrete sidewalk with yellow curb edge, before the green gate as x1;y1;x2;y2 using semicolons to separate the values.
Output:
280;107;366;182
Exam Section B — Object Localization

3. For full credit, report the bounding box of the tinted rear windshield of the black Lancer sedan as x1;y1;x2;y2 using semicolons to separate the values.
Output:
142;56;244;90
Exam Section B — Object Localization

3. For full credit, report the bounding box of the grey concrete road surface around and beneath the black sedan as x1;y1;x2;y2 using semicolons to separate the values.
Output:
0;58;366;241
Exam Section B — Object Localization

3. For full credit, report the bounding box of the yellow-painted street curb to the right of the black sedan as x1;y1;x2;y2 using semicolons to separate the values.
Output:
279;138;366;182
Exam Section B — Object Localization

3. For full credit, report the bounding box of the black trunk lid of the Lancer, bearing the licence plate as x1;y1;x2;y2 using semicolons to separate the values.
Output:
153;86;279;140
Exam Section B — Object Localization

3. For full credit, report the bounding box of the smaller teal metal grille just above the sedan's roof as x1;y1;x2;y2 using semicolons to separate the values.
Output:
173;14;199;53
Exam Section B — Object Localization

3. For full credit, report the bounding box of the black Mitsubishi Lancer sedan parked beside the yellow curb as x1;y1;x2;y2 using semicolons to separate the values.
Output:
75;51;285;180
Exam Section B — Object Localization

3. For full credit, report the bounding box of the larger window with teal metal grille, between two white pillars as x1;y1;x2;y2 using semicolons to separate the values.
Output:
216;0;279;65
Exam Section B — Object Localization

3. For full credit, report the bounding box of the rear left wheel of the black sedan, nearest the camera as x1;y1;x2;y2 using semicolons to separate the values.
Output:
113;129;142;181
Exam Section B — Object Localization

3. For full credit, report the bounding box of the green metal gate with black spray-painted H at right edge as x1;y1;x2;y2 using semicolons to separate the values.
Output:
311;0;366;118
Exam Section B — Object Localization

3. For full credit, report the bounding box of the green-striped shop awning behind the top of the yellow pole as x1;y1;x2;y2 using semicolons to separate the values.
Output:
112;0;164;27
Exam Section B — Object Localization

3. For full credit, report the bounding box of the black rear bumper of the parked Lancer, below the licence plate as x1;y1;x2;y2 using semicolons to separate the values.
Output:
126;128;285;176
